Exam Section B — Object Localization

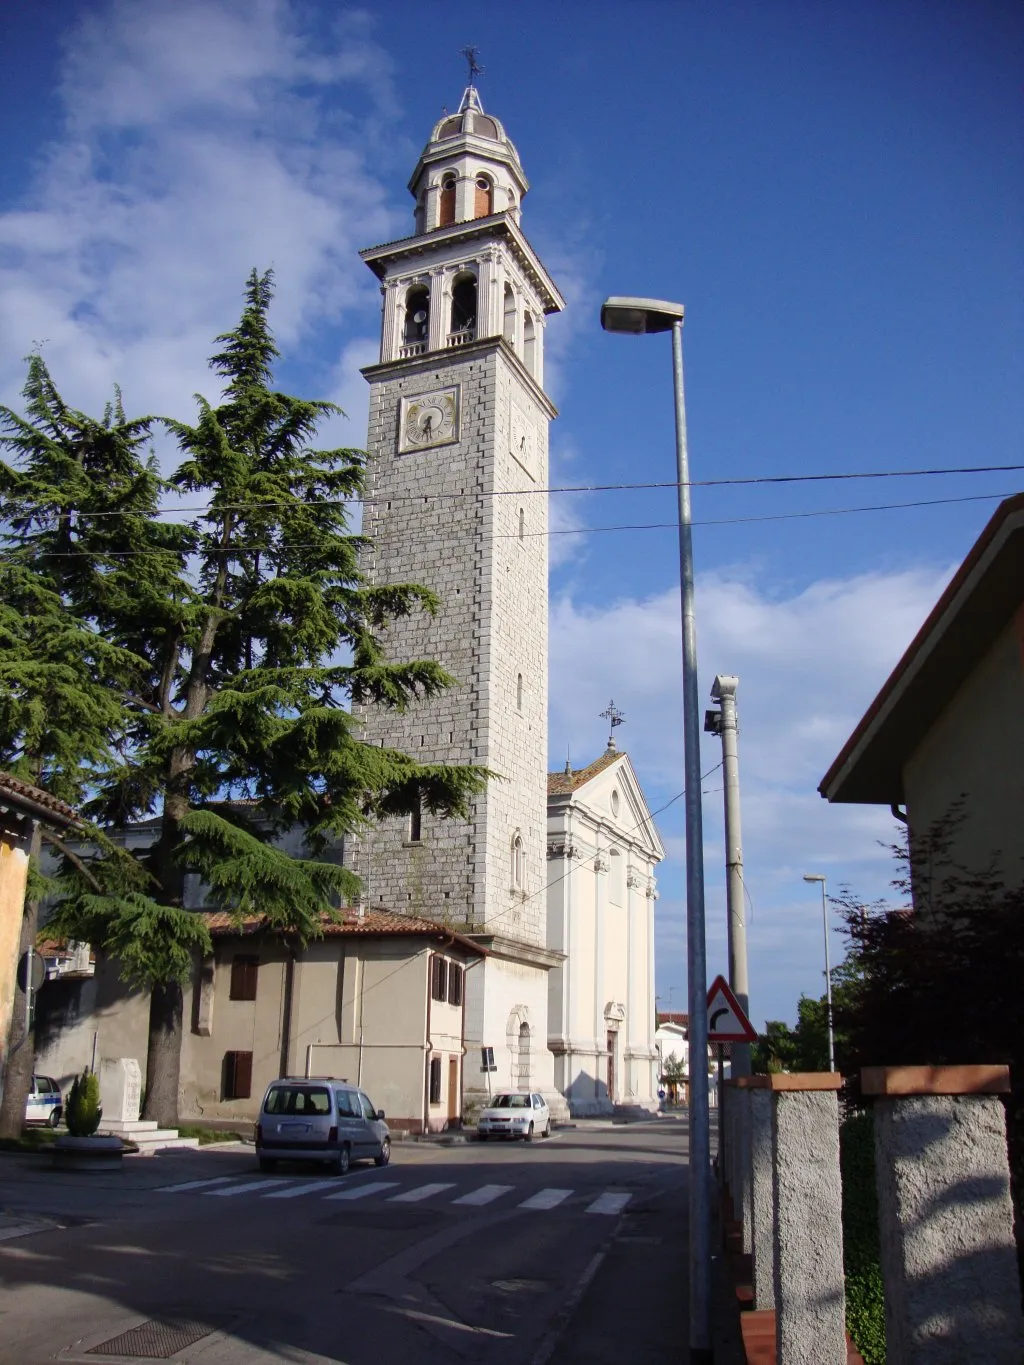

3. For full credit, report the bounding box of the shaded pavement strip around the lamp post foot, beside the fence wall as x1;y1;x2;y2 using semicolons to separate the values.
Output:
530;1162;744;1365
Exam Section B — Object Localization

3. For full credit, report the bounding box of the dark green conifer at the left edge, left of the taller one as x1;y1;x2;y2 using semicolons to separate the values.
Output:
0;355;173;1137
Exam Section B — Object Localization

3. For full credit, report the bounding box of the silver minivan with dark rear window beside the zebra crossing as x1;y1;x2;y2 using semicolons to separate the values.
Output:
255;1076;390;1175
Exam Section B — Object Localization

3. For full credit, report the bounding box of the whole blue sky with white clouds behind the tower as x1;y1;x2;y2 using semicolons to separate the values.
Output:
0;0;1024;1022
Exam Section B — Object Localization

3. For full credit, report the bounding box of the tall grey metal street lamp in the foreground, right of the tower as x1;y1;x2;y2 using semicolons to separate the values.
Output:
601;298;711;1365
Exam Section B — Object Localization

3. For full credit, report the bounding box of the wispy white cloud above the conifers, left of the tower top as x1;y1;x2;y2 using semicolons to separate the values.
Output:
0;0;396;434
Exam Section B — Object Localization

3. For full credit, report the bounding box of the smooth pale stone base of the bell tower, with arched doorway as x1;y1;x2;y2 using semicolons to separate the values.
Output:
463;934;569;1125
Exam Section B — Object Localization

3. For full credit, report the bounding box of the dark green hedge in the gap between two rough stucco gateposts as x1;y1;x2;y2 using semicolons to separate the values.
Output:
840;1111;885;1365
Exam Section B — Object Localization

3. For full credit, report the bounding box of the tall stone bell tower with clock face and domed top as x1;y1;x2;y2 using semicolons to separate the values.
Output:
350;83;564;1112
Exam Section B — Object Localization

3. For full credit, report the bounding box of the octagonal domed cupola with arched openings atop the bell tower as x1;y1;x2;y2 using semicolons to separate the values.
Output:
408;85;530;233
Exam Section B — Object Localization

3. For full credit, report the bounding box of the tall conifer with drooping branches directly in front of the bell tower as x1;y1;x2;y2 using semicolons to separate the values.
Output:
21;270;486;1123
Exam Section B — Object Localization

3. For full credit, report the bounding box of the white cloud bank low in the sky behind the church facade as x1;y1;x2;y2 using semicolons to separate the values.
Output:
550;568;950;1022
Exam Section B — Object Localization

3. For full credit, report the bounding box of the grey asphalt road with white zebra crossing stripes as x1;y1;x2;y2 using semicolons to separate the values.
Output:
0;1119;687;1365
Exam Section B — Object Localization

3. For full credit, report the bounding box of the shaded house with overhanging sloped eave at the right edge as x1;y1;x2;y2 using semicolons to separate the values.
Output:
818;494;1024;901
